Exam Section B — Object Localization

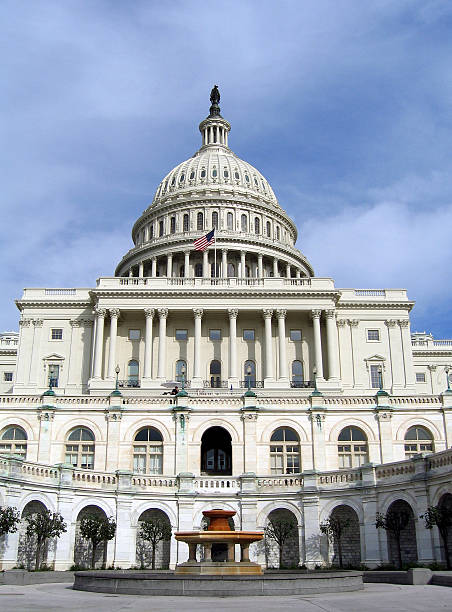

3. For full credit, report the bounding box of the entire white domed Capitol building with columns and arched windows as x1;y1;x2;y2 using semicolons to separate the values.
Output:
0;87;452;569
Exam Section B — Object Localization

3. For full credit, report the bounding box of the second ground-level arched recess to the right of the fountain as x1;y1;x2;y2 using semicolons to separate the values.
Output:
330;505;361;567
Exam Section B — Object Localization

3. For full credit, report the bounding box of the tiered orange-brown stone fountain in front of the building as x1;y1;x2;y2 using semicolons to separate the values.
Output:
174;510;264;576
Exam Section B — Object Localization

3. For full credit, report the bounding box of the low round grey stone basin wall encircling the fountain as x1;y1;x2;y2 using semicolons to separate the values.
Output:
73;570;363;597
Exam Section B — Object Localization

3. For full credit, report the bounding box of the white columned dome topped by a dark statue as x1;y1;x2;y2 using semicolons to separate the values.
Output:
115;86;313;278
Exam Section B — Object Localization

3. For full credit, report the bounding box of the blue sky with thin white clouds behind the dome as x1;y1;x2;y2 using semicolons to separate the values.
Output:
0;0;452;338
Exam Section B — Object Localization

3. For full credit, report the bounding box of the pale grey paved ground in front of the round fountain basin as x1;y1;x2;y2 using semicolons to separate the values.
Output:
0;584;452;612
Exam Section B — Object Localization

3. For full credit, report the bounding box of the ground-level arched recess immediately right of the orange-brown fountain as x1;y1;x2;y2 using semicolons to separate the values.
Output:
264;508;300;568
